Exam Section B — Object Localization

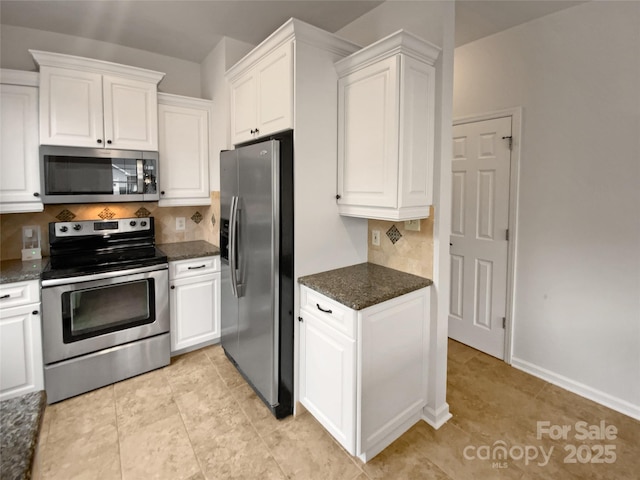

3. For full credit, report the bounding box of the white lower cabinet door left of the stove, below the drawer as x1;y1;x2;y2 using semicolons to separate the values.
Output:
0;303;44;401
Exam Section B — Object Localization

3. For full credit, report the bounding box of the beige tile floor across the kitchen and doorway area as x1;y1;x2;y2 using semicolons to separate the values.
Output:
34;341;640;480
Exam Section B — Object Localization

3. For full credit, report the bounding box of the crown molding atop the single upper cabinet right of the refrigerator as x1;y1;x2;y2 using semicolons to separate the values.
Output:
335;30;442;76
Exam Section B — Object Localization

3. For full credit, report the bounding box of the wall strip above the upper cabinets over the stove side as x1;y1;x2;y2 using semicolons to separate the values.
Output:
0;25;201;97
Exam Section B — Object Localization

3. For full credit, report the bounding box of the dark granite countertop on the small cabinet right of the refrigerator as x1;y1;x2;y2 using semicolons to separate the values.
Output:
298;263;433;310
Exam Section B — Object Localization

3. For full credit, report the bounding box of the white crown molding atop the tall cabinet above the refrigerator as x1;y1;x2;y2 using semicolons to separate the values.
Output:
226;18;362;79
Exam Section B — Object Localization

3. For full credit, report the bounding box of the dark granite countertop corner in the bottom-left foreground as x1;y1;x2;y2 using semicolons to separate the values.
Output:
0;391;46;480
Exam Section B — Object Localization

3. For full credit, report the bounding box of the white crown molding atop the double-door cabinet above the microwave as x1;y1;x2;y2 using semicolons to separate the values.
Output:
29;50;165;84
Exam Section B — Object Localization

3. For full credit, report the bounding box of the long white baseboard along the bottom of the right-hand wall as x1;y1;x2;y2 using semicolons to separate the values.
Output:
511;357;640;420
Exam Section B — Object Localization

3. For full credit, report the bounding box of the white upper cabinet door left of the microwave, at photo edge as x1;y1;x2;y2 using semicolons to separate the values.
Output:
0;85;43;213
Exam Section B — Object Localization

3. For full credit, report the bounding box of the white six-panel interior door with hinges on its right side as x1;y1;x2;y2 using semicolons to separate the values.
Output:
449;117;511;359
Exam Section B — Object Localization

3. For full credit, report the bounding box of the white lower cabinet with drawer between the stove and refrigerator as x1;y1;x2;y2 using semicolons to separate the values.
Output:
169;257;220;355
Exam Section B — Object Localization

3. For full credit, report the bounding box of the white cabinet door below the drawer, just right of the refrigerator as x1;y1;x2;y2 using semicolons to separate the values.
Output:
299;309;356;455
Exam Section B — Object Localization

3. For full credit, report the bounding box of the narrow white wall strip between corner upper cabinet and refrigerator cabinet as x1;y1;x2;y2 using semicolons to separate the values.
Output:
201;37;254;191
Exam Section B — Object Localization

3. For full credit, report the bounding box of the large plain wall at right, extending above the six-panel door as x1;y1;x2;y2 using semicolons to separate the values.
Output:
454;2;640;418
